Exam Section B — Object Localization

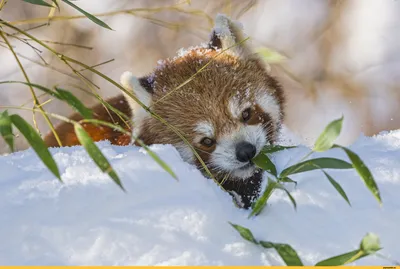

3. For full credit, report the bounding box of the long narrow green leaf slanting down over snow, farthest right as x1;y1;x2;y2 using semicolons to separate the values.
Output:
334;145;382;205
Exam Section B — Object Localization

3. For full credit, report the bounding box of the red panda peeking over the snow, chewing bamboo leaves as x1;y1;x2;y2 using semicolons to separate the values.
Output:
45;15;284;208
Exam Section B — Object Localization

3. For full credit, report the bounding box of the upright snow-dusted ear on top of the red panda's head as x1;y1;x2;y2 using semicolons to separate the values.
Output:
209;14;255;58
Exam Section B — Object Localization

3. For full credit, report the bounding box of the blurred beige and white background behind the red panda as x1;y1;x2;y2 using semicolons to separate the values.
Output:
0;0;400;153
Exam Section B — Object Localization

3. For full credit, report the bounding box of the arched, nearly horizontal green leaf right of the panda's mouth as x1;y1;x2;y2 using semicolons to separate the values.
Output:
280;158;353;178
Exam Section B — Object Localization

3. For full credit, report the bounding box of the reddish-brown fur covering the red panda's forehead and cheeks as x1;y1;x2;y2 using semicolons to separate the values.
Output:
136;49;283;161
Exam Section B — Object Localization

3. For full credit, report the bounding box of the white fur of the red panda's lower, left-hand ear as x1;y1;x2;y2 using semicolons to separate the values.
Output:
120;71;151;137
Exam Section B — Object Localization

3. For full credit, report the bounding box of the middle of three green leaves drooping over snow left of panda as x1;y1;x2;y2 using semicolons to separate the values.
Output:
74;124;125;188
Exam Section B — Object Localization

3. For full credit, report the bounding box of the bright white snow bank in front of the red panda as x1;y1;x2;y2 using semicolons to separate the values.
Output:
0;126;400;265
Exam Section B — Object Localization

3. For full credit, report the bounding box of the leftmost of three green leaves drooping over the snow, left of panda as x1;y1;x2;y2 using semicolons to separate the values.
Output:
10;114;61;181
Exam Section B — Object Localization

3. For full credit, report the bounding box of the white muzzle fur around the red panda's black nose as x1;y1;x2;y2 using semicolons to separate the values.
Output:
210;124;267;179
